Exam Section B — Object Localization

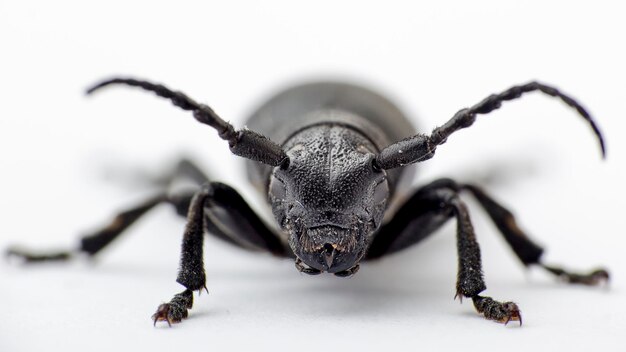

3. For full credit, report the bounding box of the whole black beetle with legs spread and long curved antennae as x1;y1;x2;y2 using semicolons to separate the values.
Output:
8;78;609;325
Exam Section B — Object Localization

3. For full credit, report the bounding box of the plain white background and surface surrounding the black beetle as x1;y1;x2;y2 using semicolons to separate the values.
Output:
0;0;626;351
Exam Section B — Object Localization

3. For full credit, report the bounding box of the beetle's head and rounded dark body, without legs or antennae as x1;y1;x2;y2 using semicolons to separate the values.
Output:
247;83;416;276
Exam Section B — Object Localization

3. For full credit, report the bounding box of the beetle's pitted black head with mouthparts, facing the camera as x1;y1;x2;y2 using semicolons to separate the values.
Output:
269;125;389;276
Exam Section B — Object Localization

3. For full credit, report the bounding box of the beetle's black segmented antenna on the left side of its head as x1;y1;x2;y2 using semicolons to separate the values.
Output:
87;78;289;166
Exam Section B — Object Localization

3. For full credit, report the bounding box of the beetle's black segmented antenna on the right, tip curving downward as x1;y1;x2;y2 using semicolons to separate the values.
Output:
375;82;606;169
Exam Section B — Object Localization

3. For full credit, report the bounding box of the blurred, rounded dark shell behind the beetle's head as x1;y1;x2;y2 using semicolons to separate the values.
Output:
246;82;417;195
